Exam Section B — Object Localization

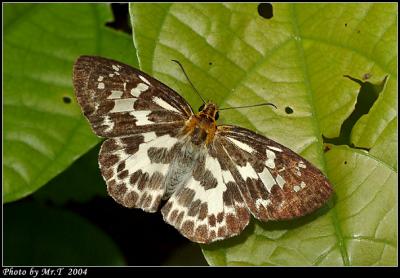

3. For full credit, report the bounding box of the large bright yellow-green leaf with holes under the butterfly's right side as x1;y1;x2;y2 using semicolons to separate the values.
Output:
130;3;397;265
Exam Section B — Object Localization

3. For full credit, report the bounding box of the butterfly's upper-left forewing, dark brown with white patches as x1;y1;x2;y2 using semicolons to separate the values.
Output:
73;56;193;137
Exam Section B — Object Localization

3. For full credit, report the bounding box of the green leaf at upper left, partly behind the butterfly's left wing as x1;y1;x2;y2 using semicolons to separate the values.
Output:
3;3;136;202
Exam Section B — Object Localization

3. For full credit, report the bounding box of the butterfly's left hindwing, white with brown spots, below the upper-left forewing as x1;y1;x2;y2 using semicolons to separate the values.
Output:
99;130;183;212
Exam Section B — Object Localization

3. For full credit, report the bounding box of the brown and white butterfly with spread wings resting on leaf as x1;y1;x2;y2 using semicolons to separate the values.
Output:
73;56;332;243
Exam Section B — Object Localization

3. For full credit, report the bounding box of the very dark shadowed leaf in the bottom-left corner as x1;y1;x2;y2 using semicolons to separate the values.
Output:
4;202;125;266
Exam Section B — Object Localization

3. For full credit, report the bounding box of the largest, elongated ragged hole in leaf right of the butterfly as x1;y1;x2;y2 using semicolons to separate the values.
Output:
322;75;387;151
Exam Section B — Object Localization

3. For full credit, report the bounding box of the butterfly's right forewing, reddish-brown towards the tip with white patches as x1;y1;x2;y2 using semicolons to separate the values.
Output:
215;125;332;221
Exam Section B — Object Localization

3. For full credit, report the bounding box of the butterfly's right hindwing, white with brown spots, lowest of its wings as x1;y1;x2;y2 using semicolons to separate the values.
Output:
161;143;250;243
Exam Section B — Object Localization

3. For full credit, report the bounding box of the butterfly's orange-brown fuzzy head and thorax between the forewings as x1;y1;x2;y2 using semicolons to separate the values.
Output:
184;103;218;146
